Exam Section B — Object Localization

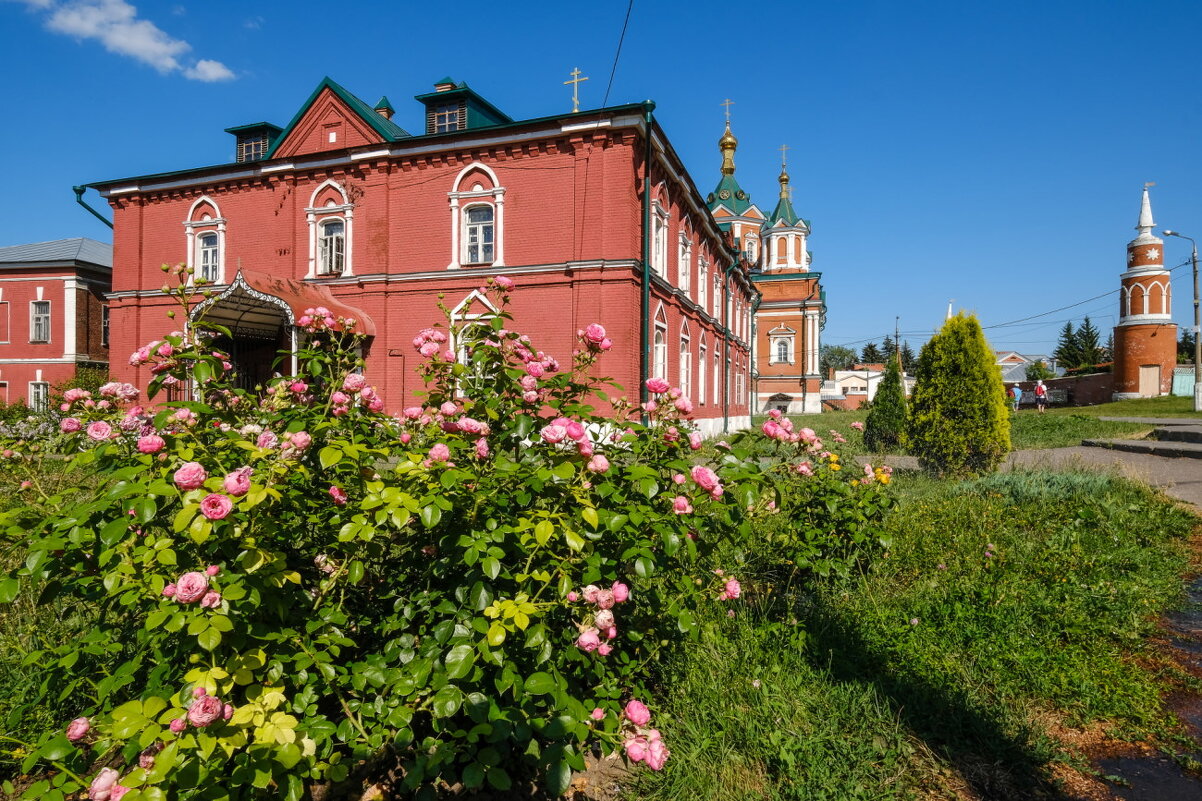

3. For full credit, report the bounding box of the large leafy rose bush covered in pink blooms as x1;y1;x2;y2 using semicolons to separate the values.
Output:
0;271;887;801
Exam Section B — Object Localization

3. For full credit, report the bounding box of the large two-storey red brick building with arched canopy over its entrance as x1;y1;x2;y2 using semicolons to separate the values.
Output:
91;78;756;433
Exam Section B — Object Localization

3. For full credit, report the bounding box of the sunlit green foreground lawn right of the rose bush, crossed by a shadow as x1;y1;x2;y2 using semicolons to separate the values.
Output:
631;473;1197;801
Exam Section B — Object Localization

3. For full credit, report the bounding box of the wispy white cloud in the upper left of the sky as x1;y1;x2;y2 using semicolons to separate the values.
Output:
8;0;234;82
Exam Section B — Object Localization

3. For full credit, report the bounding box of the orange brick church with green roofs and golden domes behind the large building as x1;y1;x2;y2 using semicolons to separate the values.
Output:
707;121;826;414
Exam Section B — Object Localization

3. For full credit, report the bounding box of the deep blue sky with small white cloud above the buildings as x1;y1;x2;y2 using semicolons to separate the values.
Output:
0;0;1202;352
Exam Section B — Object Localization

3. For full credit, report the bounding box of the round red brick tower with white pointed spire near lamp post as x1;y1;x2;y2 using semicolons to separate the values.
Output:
1114;186;1177;401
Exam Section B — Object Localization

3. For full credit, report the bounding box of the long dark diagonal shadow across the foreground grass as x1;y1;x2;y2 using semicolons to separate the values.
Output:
805;604;1067;801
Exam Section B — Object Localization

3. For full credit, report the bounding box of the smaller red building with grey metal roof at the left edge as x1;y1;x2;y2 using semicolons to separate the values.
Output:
0;238;113;409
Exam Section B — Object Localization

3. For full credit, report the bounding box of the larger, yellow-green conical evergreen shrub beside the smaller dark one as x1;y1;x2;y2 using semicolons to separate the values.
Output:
906;314;1010;476
